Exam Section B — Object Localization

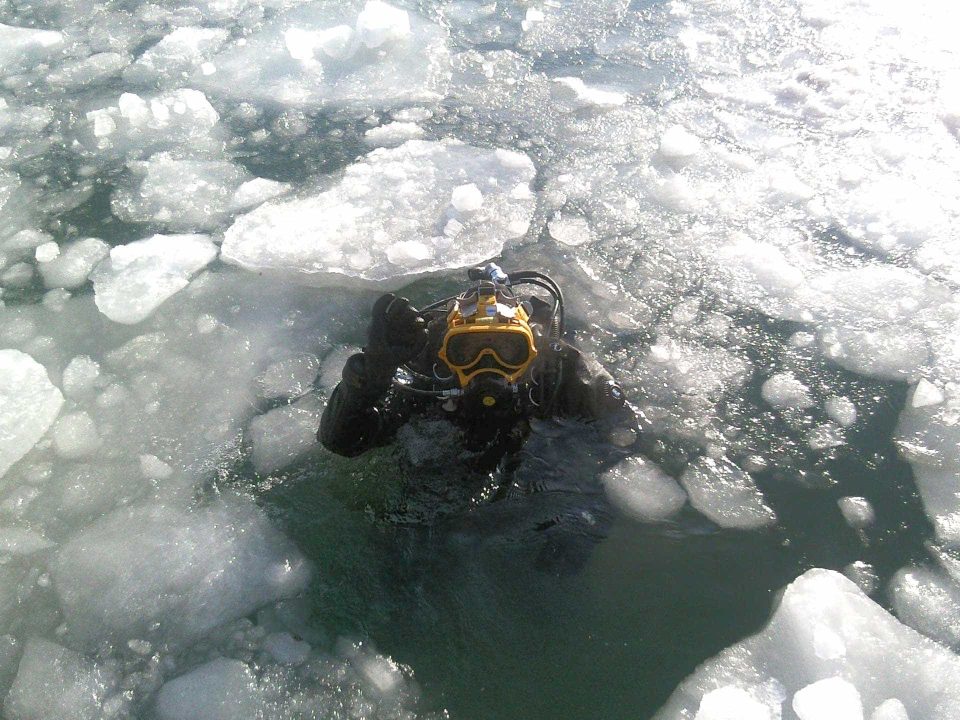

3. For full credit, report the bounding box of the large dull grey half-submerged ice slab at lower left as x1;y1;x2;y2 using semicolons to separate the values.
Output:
50;497;309;645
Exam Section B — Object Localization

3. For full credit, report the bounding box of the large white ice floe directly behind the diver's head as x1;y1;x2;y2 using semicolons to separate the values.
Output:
221;140;534;287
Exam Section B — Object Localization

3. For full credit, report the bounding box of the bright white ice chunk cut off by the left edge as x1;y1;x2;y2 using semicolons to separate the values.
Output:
0;350;63;477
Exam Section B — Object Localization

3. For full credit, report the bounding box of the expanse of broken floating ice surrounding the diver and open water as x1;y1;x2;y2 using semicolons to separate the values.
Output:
0;0;960;720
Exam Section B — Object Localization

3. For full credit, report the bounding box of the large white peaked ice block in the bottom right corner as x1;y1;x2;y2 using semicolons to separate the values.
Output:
656;569;960;720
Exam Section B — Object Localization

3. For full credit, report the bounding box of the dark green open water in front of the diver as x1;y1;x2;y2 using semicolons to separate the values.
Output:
261;358;930;720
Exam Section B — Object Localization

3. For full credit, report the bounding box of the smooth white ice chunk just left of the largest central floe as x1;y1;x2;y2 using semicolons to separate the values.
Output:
92;235;217;325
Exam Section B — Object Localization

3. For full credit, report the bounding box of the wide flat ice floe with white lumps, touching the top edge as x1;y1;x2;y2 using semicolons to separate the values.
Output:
193;0;449;112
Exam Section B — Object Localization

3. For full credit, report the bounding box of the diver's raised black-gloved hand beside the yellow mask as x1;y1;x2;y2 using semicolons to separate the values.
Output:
364;293;427;377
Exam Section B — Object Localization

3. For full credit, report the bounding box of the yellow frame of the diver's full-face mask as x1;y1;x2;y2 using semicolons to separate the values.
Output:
437;286;537;388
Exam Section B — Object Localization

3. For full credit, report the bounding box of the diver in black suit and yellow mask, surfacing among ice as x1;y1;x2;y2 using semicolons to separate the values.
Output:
317;263;639;472
